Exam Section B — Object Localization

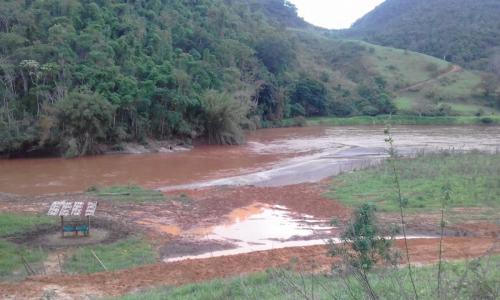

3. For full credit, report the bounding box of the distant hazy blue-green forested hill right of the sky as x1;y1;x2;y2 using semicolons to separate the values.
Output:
346;0;500;73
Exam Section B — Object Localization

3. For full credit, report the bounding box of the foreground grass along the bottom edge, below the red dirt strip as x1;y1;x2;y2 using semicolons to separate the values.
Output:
119;256;500;300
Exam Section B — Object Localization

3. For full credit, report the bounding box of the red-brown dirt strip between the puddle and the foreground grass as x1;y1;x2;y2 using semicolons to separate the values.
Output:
0;238;500;299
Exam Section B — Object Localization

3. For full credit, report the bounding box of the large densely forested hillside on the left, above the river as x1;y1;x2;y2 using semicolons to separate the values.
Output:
0;0;494;156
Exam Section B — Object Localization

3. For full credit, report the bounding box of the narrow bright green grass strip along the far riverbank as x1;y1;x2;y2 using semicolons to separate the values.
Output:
307;115;500;126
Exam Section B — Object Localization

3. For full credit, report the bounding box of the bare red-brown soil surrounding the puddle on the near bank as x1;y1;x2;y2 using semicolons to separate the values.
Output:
0;182;500;299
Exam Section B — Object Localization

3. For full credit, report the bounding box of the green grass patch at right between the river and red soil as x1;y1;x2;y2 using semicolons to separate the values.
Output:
328;153;500;212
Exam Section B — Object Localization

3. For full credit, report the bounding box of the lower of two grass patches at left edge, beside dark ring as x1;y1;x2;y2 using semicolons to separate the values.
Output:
0;239;47;280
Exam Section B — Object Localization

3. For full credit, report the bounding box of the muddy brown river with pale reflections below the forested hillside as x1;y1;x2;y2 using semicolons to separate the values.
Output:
0;126;500;195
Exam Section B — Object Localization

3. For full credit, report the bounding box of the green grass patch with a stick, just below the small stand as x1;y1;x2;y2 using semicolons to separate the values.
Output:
63;238;156;273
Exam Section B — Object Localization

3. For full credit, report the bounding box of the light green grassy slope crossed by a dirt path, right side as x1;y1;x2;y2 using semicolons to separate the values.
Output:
360;42;498;115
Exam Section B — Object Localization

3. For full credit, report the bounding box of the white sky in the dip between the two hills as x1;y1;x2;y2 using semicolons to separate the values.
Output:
289;0;384;29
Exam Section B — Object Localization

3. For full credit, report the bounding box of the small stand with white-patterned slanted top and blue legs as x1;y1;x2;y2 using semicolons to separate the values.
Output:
47;201;98;237
